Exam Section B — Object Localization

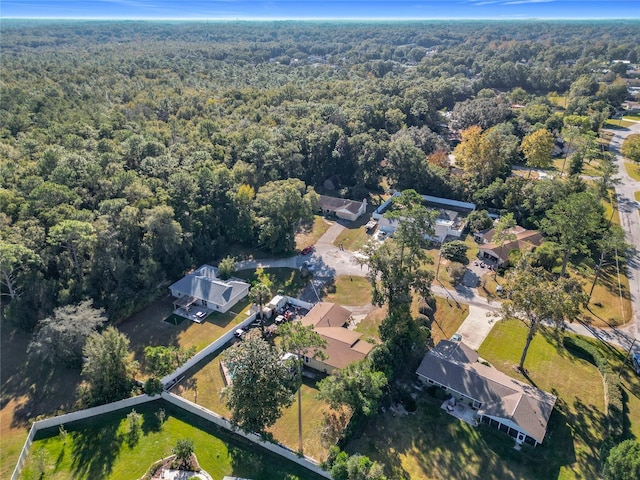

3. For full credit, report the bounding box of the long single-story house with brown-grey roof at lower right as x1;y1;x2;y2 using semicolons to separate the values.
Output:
416;340;557;446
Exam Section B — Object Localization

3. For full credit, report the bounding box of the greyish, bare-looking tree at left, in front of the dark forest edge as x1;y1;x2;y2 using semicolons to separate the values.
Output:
27;300;107;365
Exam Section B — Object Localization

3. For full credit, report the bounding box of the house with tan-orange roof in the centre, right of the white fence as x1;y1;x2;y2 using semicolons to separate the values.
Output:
301;302;373;373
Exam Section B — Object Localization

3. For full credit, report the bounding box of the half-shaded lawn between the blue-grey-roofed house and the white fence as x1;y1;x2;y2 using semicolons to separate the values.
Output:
118;296;251;364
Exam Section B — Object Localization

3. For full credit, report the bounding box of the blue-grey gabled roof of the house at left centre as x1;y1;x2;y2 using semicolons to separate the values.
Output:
169;265;249;305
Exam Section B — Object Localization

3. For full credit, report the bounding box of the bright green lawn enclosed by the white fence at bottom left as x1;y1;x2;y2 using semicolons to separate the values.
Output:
21;400;318;480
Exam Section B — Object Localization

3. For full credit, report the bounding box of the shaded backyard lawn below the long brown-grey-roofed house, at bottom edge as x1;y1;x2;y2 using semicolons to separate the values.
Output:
345;393;557;480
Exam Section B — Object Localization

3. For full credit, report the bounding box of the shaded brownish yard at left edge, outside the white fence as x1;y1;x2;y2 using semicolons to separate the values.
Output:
0;323;80;478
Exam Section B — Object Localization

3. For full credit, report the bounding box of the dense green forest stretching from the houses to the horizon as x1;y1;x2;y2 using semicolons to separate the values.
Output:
0;20;640;329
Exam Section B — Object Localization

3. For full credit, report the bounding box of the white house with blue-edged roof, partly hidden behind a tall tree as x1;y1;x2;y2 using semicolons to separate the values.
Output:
372;192;476;243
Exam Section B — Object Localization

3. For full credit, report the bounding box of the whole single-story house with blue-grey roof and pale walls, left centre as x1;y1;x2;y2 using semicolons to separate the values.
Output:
169;265;249;313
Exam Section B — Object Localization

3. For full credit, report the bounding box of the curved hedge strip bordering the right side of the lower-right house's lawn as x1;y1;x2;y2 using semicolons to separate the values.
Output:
563;337;624;438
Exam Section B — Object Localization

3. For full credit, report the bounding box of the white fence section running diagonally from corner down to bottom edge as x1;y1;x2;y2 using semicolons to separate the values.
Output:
162;392;331;479
